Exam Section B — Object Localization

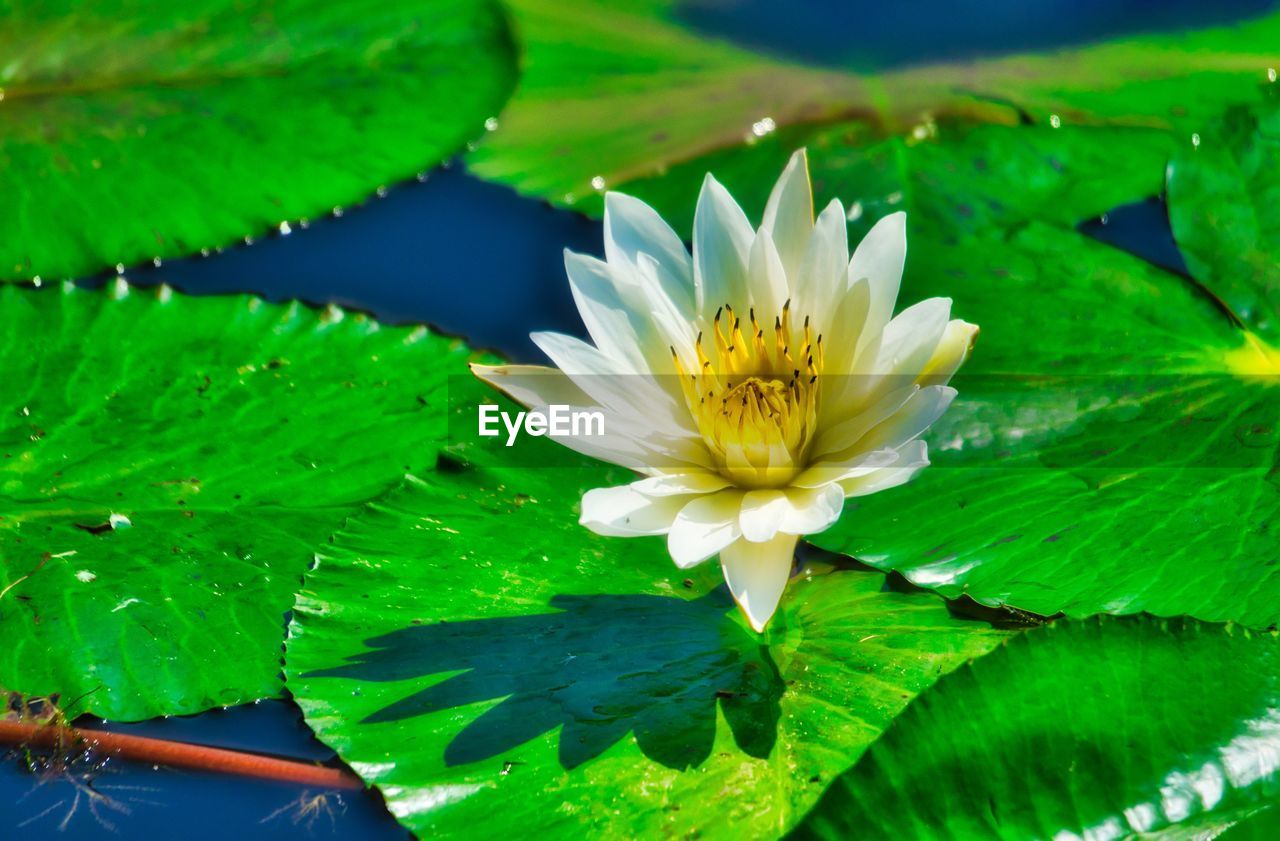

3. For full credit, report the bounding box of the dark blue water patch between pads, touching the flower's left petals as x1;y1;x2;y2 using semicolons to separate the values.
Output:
107;166;604;358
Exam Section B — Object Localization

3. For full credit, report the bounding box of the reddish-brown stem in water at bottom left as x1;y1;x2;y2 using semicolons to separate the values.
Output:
0;719;364;790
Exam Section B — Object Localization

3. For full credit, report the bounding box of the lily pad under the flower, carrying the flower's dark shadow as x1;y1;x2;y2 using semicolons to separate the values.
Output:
287;455;1007;837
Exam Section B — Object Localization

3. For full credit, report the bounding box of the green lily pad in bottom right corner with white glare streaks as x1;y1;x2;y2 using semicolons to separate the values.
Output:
794;617;1280;840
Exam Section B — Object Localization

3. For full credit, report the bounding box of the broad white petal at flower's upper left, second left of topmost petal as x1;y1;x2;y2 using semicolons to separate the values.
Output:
604;192;694;319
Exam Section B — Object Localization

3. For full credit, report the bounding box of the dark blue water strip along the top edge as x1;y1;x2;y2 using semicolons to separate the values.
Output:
677;0;1276;70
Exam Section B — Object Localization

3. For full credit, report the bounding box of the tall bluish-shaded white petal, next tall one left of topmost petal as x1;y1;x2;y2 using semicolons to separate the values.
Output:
694;174;753;320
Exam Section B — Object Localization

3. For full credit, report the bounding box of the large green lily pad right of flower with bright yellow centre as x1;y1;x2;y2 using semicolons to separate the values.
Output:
814;110;1280;627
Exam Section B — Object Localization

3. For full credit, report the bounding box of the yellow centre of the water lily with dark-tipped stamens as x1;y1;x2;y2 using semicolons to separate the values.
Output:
672;301;822;488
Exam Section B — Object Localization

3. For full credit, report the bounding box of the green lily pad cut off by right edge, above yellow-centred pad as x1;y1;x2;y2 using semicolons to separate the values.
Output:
1169;97;1280;343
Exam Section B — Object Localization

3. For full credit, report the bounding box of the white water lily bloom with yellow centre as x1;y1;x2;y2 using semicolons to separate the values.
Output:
474;151;978;631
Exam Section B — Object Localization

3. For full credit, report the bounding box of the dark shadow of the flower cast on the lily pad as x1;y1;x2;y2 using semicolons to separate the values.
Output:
307;588;785;769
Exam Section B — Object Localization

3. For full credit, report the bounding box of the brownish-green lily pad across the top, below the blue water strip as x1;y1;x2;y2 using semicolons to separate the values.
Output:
467;0;1280;213
